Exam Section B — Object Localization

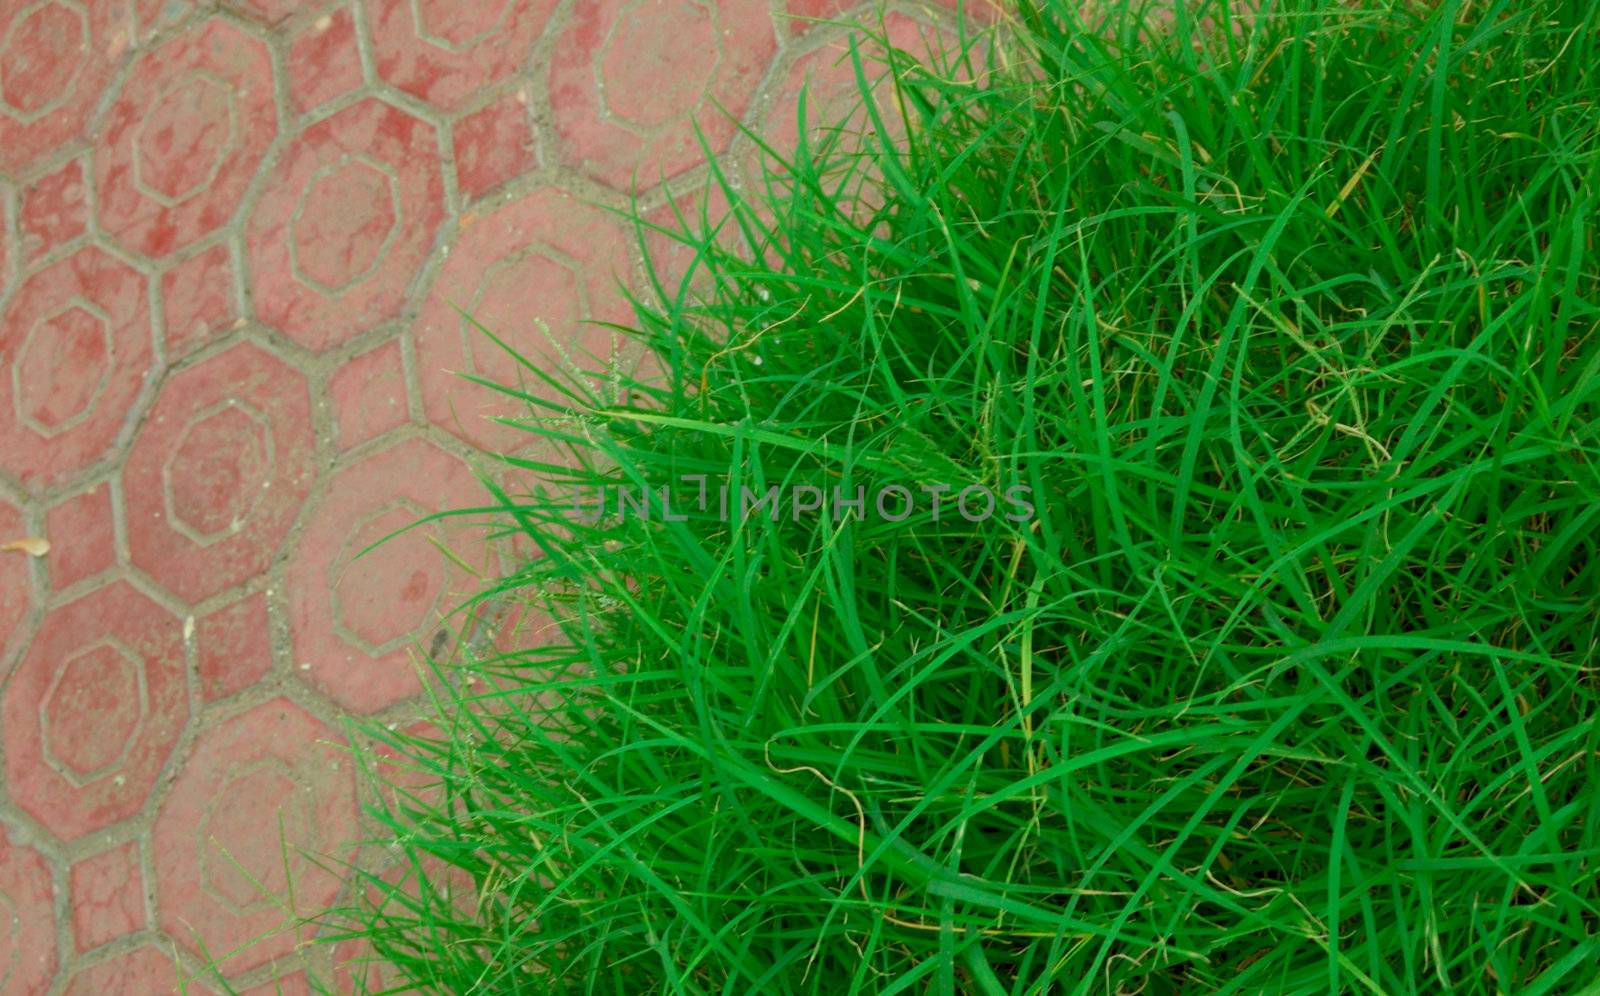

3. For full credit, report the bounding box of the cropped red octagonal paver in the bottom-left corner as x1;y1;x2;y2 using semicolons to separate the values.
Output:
0;826;58;996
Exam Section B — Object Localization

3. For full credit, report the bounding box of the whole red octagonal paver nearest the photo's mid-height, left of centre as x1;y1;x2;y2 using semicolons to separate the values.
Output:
122;343;315;602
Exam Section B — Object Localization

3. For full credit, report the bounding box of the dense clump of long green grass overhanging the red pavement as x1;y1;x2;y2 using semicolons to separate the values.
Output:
340;0;1600;994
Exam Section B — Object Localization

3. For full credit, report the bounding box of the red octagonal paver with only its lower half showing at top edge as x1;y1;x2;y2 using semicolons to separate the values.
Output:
366;0;555;109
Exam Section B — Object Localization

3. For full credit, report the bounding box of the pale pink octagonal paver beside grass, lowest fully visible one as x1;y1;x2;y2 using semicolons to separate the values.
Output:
152;698;357;974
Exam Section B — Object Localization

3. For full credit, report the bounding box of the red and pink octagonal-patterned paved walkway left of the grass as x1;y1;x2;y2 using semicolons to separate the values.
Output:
0;0;972;996
